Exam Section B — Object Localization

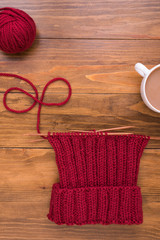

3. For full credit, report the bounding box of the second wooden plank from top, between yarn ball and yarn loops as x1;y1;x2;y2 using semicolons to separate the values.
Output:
0;39;160;93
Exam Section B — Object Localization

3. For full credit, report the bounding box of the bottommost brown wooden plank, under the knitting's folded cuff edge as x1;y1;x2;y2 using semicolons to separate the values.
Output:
0;201;160;240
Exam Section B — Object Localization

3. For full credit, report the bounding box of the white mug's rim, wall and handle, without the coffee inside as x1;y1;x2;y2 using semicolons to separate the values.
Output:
135;63;160;113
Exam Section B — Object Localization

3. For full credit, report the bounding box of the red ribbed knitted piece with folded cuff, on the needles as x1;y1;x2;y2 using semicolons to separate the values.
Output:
48;132;149;225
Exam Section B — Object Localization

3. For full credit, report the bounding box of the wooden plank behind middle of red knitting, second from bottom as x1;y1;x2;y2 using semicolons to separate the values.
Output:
0;148;160;196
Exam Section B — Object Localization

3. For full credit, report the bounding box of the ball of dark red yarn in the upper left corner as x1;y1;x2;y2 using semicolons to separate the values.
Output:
0;7;36;53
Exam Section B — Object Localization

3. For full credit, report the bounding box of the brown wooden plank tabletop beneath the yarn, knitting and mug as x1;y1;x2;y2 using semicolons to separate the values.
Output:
0;0;160;240
